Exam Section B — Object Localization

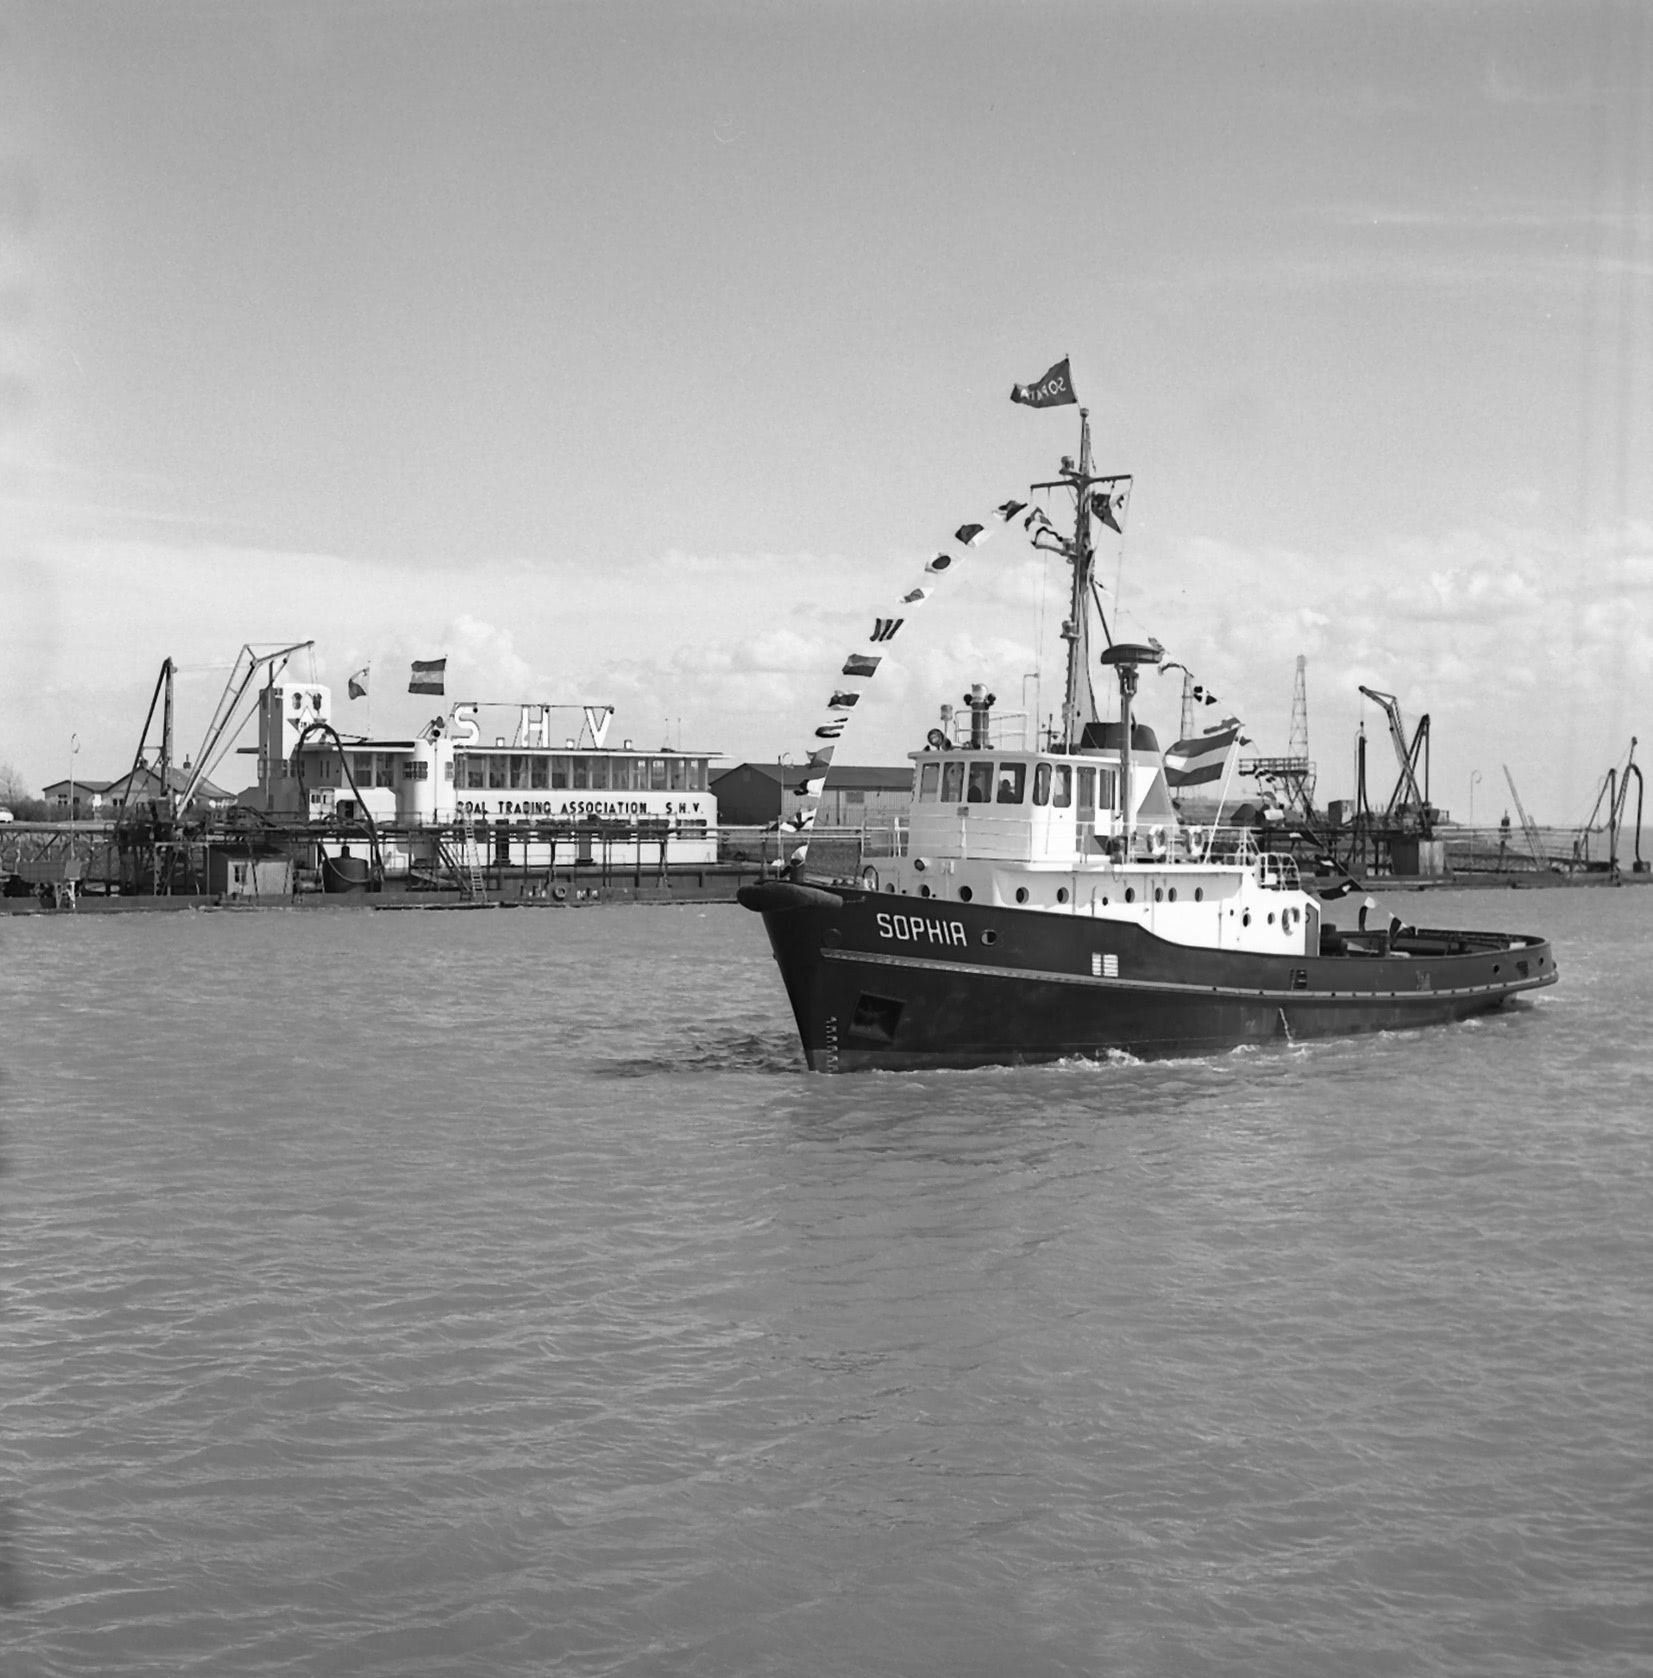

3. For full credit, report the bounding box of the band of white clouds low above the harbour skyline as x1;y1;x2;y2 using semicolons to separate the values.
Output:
0;524;1653;819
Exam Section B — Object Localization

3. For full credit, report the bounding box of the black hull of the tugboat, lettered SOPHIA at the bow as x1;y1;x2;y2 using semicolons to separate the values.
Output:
740;881;1556;1072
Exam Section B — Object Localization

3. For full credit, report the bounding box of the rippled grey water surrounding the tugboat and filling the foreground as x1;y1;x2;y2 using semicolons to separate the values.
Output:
0;889;1653;1678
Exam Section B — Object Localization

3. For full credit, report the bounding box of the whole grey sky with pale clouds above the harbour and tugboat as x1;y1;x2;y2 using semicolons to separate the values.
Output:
0;0;1653;821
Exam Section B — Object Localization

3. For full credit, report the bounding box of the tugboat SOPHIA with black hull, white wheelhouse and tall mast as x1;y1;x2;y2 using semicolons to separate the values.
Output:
738;409;1557;1072
